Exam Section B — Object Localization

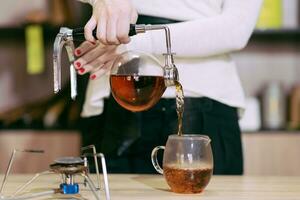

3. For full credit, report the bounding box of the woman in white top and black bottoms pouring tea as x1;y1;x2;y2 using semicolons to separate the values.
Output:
75;0;262;174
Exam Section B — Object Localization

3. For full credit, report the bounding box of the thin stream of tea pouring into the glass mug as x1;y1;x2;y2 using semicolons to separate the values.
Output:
175;81;184;136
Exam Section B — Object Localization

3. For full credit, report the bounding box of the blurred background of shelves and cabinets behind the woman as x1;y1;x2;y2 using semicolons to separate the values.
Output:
0;0;300;175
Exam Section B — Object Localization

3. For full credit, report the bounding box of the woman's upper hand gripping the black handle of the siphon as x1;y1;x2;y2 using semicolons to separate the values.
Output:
84;0;137;45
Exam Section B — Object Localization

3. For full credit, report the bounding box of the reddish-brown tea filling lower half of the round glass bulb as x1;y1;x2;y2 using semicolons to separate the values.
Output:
110;75;166;112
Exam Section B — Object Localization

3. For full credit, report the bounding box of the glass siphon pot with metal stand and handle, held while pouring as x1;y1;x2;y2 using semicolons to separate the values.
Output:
53;24;179;112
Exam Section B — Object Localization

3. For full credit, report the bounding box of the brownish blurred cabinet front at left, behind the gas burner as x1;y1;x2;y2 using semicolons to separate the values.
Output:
0;130;81;173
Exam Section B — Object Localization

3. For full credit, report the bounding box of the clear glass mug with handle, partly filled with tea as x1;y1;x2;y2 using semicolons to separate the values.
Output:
151;135;213;194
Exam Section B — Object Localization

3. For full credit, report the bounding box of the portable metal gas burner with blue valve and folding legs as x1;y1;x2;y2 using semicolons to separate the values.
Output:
0;145;110;200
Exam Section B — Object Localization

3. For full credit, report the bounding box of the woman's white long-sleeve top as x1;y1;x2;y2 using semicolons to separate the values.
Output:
82;0;262;117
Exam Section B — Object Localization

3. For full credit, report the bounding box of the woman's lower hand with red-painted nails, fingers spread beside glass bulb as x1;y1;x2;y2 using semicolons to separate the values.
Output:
74;41;118;80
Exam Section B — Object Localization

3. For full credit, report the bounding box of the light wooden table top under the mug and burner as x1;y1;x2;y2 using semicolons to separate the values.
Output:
1;174;300;200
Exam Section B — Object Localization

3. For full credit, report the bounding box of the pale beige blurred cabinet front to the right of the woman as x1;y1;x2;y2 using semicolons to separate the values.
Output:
242;132;300;176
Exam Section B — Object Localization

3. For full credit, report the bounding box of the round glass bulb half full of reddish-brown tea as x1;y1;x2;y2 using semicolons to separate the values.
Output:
110;51;166;112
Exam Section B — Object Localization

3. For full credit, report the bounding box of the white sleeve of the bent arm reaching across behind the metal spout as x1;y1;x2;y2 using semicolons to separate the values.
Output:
127;0;262;57
